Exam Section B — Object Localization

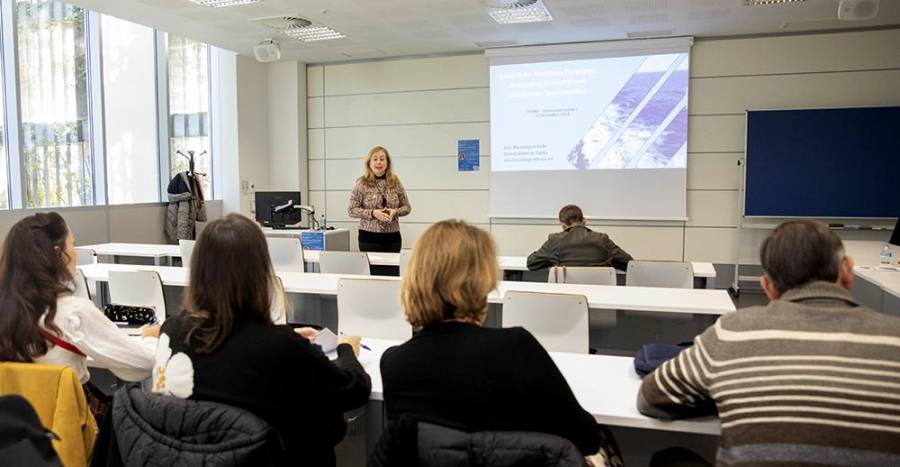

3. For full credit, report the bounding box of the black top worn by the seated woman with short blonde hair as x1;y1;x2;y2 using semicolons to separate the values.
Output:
381;321;600;455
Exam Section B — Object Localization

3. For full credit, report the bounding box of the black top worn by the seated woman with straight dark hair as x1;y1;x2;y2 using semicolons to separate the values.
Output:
161;316;372;466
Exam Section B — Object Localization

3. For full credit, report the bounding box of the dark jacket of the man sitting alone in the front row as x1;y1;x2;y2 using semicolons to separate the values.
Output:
528;224;633;271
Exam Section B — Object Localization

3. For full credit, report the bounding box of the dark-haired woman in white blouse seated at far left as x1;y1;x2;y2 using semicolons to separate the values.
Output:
0;212;159;384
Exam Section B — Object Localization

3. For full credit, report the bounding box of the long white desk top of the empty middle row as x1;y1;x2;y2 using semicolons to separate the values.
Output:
79;263;735;315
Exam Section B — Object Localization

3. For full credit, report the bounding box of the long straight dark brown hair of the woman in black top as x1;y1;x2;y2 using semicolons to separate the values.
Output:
183;214;275;353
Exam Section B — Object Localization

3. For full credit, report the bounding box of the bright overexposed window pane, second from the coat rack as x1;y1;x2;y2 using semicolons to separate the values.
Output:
100;15;159;204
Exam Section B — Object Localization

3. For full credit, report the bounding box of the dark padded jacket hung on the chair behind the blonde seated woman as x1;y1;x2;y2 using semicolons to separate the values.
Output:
369;418;585;467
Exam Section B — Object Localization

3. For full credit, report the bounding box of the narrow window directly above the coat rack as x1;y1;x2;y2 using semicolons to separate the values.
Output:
168;34;212;198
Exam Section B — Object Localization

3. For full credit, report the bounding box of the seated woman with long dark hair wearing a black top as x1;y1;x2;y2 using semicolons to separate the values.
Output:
153;214;371;465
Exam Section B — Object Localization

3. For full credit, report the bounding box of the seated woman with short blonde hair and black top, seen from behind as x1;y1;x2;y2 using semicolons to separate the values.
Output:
372;221;600;464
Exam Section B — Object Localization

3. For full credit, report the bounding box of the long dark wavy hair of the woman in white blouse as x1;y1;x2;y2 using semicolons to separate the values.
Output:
0;212;72;362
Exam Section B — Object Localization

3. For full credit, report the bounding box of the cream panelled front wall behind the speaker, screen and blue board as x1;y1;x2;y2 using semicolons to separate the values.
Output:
307;29;900;263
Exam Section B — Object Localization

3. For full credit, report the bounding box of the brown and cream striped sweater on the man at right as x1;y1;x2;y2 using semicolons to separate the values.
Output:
638;282;900;466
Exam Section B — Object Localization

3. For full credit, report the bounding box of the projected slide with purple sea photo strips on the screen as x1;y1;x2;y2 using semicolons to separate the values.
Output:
491;53;689;172
